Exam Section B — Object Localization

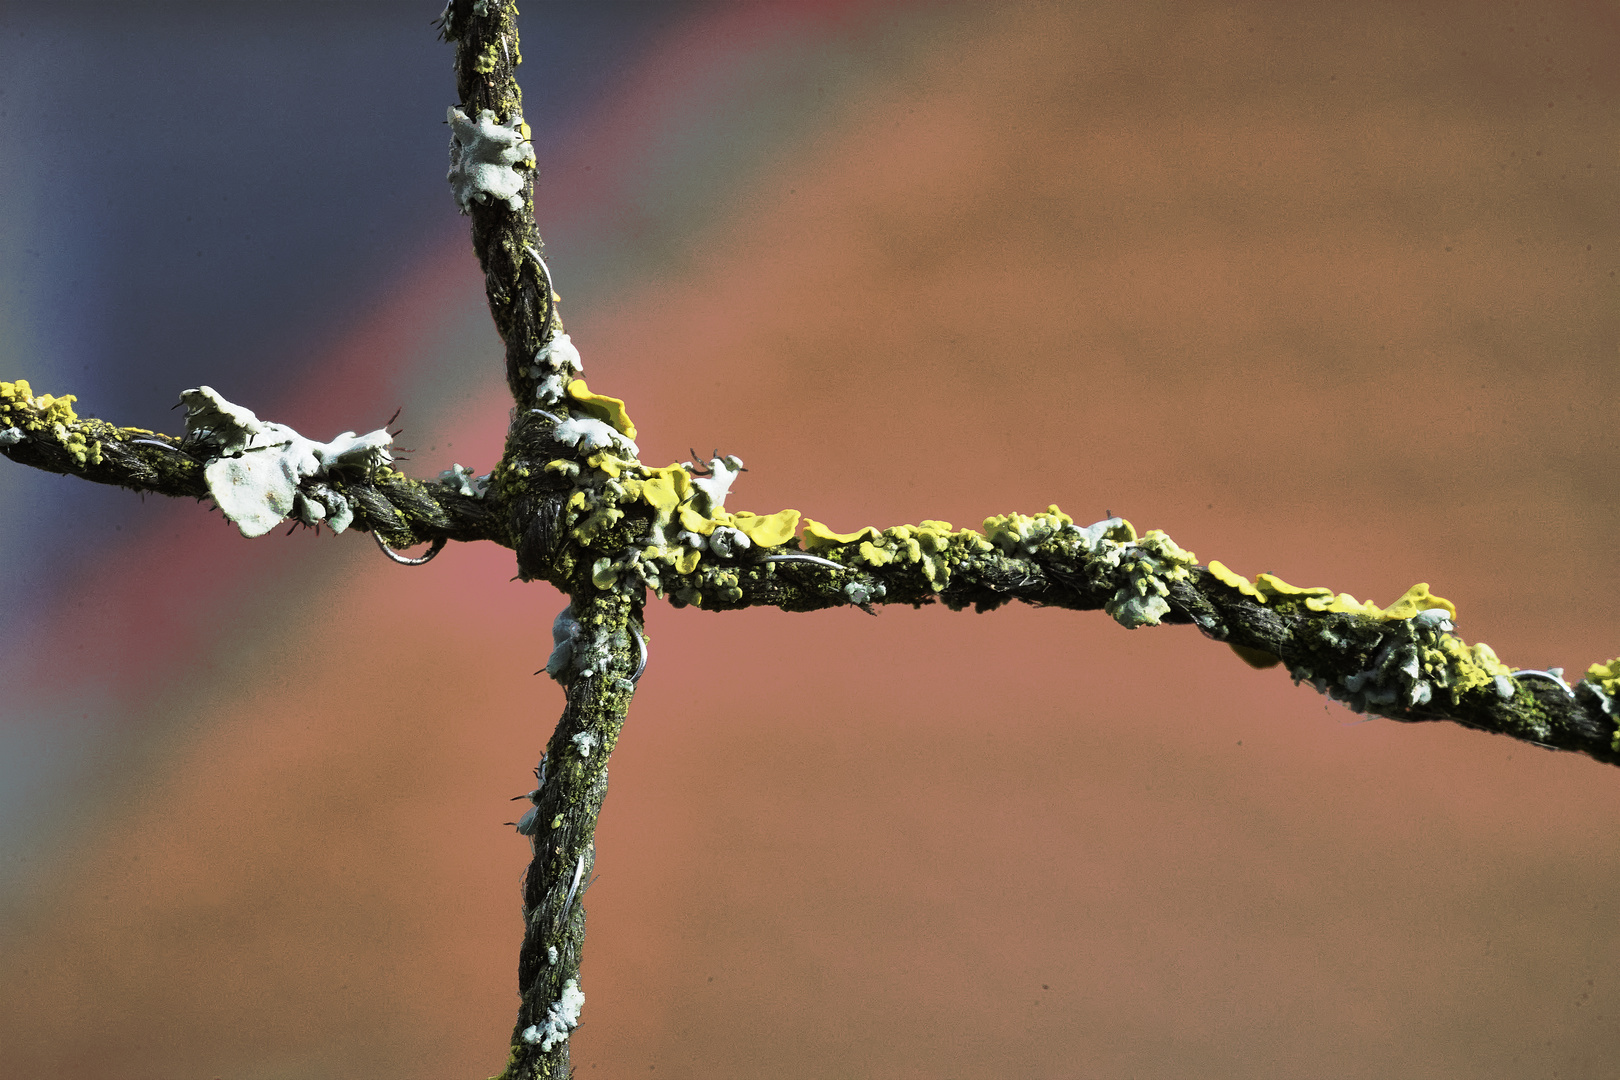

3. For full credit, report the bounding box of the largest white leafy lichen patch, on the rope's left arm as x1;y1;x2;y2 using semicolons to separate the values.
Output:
180;387;394;538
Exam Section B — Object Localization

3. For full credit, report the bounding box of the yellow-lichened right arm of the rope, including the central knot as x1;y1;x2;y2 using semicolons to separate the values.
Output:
492;396;1620;764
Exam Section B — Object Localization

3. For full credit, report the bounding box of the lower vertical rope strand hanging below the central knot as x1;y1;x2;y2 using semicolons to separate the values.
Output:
502;593;645;1080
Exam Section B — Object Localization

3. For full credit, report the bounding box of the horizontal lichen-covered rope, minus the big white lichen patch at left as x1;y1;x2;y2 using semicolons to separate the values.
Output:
0;381;1620;764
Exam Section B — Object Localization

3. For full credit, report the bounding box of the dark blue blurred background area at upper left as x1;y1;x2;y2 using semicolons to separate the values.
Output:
0;0;690;592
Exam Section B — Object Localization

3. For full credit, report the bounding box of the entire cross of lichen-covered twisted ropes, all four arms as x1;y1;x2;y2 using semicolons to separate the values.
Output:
0;2;1620;1077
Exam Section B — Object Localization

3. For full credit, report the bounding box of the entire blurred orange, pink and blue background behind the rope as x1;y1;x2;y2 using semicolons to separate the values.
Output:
0;0;1620;1080
